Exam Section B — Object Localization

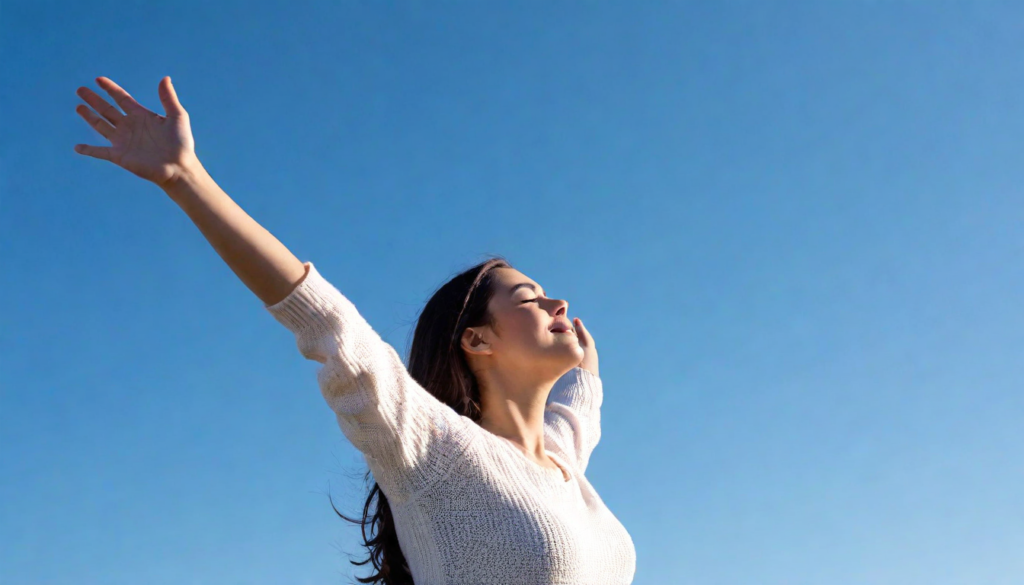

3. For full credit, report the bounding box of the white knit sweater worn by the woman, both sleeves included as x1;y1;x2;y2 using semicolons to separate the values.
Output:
266;262;636;585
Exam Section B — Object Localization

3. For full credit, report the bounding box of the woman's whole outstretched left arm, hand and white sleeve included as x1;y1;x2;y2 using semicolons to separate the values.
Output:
75;77;476;503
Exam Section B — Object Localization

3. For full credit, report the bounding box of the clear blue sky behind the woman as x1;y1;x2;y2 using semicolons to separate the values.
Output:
0;0;1024;585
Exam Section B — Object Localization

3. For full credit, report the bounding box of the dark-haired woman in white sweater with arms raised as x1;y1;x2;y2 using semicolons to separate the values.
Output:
75;77;636;585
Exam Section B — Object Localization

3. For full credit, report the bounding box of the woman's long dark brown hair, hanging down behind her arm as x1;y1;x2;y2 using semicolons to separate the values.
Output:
331;255;512;585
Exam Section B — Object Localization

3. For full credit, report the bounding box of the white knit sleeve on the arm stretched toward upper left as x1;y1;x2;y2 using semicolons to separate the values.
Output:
264;262;472;504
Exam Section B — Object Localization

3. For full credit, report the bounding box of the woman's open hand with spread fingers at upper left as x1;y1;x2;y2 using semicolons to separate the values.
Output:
75;77;197;187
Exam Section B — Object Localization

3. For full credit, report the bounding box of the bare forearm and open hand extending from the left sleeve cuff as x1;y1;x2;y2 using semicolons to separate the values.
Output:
75;77;306;304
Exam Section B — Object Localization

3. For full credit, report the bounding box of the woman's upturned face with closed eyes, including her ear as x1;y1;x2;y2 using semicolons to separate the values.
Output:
463;268;584;372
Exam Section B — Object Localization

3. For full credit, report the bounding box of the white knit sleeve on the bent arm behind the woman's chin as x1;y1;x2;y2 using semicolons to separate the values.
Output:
544;367;604;473
